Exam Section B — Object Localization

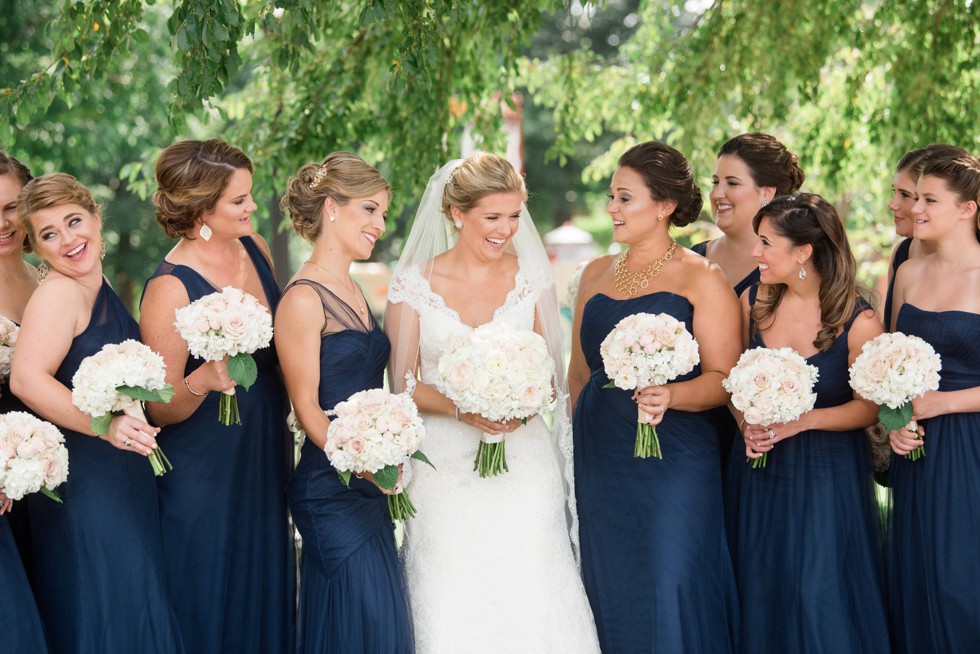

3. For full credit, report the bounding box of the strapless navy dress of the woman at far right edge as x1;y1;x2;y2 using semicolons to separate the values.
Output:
889;304;980;654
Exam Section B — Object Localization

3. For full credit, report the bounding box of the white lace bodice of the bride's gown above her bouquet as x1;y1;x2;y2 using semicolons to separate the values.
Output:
388;260;551;384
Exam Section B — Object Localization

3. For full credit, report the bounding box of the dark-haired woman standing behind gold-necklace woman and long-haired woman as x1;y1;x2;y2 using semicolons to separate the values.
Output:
691;132;806;478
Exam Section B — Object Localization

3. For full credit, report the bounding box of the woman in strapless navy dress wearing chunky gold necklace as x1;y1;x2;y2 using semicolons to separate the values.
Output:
568;142;739;653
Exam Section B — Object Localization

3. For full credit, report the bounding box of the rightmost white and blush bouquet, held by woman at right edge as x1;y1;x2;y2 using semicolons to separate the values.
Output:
850;332;942;461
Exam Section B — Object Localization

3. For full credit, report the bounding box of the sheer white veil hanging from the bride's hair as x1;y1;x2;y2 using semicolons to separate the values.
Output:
385;159;579;559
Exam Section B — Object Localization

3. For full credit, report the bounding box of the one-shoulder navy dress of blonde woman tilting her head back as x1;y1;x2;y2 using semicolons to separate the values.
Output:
26;280;184;654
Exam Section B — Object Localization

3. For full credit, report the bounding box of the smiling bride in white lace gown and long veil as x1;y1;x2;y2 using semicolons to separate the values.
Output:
385;153;599;654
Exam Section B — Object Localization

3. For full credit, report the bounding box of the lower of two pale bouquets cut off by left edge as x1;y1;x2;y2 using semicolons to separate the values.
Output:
0;411;68;504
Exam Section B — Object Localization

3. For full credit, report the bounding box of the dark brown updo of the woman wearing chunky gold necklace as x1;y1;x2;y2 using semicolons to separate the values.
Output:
619;141;704;227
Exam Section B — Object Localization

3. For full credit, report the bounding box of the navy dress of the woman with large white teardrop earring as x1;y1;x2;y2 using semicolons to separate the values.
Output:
144;237;295;654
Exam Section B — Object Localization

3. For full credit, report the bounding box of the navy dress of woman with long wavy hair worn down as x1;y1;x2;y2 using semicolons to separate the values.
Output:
725;287;890;654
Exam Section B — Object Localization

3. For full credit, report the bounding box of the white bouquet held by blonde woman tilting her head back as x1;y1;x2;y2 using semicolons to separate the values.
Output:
71;339;174;477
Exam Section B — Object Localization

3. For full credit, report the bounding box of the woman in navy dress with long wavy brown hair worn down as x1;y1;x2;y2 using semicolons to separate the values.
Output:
726;193;889;654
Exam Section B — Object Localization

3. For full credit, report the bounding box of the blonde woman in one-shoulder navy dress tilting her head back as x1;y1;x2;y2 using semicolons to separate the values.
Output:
10;173;184;653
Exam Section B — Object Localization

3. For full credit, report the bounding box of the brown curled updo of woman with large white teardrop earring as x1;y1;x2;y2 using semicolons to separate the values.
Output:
153;139;254;238
